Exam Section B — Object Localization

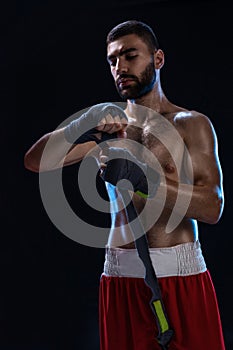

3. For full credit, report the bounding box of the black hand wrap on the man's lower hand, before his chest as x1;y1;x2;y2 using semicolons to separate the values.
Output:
101;147;160;198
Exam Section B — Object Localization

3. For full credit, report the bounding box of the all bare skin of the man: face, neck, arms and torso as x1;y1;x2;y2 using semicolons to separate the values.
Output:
25;34;224;248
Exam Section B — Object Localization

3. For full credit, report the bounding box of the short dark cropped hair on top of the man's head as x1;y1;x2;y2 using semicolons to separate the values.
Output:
106;20;159;52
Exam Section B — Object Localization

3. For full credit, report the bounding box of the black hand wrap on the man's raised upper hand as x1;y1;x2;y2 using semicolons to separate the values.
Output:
64;102;128;144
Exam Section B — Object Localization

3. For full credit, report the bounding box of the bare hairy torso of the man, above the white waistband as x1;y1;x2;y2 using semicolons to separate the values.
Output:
108;104;197;249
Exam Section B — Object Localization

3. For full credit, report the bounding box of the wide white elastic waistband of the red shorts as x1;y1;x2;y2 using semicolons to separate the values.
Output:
103;241;206;278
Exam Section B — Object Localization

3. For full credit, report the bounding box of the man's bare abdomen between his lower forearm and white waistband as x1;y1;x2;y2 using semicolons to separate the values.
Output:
106;183;198;249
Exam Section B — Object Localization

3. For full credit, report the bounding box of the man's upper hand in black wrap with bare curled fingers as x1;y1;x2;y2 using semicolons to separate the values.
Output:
64;102;128;144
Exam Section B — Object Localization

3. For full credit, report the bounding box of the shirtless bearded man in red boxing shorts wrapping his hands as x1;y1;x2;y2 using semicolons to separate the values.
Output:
25;21;225;350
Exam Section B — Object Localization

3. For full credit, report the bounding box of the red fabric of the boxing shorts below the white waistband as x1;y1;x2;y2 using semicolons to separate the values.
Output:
99;271;225;350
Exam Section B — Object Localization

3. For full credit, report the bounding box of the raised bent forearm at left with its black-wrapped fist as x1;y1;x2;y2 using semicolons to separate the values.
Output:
24;103;127;172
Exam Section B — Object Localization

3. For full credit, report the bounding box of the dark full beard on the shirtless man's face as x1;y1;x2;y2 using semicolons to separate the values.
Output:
116;62;156;100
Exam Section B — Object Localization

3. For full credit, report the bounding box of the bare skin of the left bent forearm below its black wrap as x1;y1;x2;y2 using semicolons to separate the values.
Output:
24;129;96;172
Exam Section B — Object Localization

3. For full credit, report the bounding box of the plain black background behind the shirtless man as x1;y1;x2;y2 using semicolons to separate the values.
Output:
0;0;233;350
